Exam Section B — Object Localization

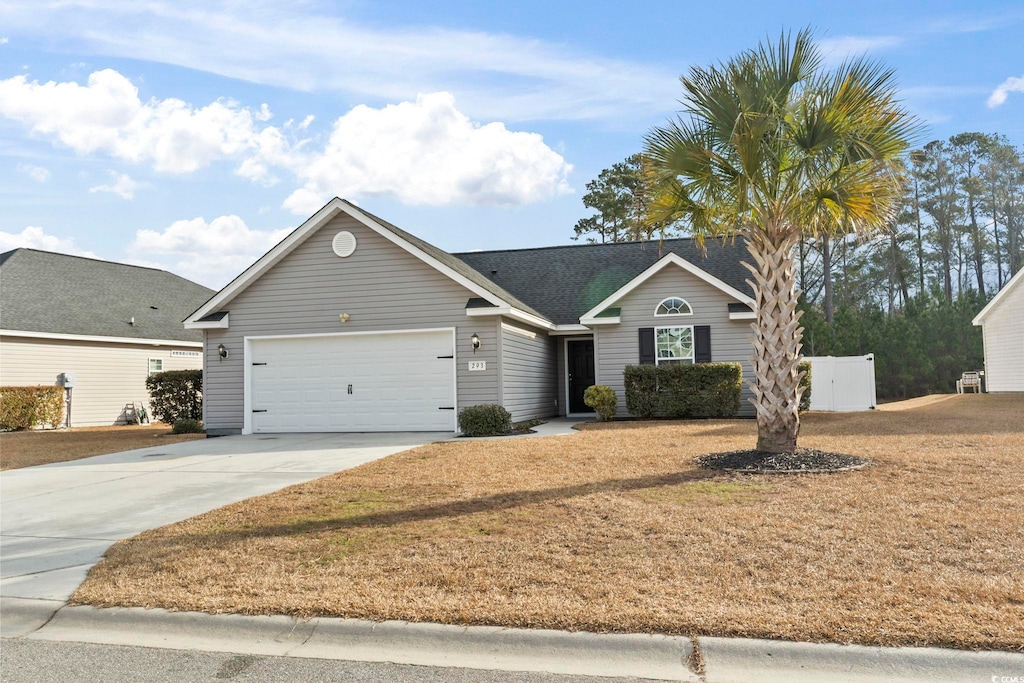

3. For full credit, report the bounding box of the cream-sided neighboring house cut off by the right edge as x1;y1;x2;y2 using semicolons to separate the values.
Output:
974;268;1024;392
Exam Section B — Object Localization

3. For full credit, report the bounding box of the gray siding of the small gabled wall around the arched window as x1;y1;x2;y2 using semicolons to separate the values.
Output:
594;265;754;417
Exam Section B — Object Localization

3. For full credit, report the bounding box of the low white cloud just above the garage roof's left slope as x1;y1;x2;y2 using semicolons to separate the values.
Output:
129;215;292;289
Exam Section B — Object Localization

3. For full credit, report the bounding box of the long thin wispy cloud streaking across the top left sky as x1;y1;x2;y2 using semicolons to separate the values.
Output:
3;0;679;124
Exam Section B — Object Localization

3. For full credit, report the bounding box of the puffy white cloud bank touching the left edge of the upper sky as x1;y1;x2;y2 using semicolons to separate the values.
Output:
0;69;299;179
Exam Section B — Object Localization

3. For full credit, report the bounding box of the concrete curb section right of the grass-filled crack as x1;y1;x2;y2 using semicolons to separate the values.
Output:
699;638;1024;683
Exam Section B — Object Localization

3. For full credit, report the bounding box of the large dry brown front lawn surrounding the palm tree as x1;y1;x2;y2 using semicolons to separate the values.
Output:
74;394;1024;650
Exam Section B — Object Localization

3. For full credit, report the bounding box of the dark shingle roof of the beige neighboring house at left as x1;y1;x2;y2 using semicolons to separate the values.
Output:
0;249;214;341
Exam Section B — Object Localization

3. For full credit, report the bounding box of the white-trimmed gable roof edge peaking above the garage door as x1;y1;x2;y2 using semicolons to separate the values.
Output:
185;198;543;328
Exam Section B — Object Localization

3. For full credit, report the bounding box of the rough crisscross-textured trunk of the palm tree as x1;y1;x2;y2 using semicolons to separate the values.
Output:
746;230;804;453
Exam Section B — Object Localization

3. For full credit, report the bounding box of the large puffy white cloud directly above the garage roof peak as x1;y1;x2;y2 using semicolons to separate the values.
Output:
285;92;572;214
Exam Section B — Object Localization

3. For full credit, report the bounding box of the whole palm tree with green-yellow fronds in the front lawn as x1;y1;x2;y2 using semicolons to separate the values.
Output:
645;30;918;453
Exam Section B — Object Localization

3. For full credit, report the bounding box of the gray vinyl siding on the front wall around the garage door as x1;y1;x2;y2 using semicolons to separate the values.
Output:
205;215;500;433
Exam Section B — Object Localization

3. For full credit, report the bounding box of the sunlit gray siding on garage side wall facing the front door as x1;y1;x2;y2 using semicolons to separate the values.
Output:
499;322;558;422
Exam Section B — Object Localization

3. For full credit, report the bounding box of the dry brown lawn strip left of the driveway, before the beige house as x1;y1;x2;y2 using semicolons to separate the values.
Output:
0;423;205;470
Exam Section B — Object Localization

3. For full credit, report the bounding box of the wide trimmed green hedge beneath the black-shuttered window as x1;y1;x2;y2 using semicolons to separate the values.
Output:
623;362;743;419
